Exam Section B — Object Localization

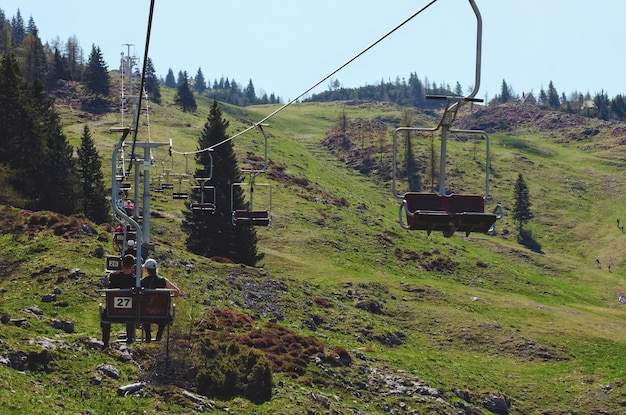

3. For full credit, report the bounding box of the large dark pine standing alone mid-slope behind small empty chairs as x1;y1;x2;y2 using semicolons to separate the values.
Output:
182;101;260;265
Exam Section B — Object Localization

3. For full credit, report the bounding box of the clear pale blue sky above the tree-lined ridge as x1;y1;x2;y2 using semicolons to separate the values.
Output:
0;0;626;102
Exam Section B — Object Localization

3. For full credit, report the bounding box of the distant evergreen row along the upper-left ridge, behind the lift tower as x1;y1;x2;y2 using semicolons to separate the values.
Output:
0;9;272;112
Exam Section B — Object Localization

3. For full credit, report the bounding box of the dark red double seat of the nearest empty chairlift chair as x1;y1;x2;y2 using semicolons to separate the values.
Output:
400;192;497;237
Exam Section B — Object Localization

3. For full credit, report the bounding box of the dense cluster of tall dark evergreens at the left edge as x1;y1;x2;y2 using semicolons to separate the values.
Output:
0;54;110;223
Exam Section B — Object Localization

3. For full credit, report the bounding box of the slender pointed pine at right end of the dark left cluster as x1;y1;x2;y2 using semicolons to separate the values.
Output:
77;125;111;223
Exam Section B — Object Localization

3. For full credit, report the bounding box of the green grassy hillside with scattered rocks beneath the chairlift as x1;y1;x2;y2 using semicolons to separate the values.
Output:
0;89;626;414
